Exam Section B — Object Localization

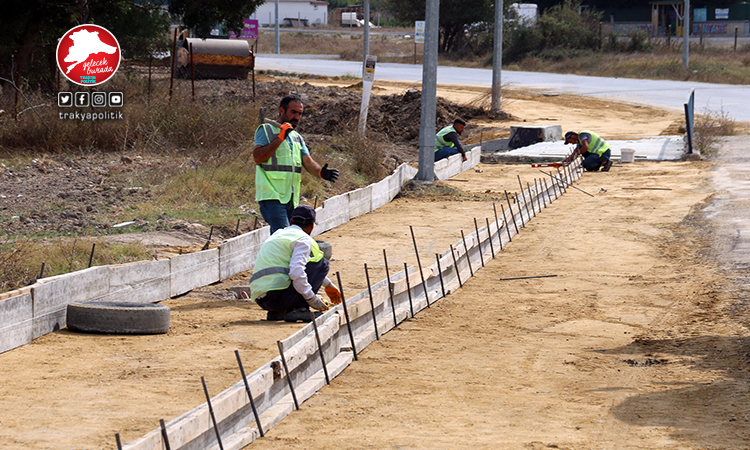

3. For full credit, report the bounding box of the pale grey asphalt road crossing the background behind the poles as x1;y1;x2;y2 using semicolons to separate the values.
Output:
255;54;750;122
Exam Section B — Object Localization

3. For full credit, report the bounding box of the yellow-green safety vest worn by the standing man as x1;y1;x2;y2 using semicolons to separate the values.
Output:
255;123;303;208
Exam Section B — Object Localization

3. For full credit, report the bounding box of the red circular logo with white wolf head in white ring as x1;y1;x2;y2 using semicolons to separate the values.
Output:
57;24;120;86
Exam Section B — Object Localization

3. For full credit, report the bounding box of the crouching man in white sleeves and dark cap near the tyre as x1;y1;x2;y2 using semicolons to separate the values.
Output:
250;205;341;322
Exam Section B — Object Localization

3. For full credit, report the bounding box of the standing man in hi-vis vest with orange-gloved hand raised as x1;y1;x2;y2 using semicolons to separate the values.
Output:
253;95;339;234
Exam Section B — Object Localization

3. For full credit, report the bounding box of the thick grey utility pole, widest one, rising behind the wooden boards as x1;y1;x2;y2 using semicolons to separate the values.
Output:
415;0;440;181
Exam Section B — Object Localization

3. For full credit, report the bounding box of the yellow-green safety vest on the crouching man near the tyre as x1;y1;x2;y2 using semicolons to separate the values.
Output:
250;225;323;301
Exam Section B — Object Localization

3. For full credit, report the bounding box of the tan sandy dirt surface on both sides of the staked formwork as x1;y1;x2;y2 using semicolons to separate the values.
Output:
0;82;750;449
